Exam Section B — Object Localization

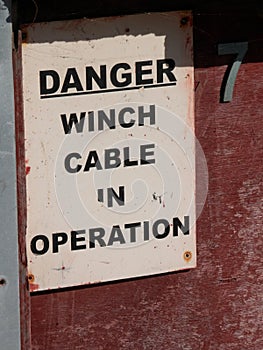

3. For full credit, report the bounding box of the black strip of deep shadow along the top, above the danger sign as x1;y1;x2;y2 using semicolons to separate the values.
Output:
16;0;263;23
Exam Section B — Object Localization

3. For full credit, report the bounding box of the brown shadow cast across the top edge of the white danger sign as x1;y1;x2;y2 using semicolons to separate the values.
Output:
22;11;192;67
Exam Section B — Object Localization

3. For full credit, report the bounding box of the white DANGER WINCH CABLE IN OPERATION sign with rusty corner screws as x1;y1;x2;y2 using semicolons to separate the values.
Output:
22;12;196;291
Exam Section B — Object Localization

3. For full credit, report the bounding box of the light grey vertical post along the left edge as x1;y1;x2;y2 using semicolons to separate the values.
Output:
0;0;21;350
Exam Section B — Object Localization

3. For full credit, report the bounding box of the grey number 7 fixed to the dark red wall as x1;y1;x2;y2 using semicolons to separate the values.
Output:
218;41;248;102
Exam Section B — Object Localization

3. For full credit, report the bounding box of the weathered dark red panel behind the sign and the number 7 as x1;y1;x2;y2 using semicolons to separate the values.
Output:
31;8;263;350
